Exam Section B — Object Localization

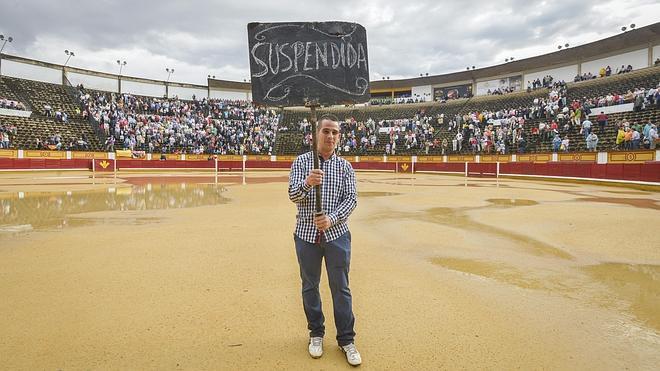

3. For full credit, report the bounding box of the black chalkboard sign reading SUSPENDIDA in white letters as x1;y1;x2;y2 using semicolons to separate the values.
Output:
248;22;369;107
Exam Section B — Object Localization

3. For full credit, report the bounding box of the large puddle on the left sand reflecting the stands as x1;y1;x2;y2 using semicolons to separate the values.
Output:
0;183;229;235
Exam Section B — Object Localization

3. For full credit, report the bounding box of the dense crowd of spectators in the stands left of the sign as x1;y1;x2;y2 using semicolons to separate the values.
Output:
79;86;279;155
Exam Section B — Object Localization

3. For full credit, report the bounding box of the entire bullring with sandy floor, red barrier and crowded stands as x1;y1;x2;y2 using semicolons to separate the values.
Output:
0;18;660;370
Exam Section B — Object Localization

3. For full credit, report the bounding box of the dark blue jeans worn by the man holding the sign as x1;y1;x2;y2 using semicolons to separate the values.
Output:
293;232;355;346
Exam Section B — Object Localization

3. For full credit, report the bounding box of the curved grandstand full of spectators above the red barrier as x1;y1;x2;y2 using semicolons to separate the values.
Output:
0;24;660;168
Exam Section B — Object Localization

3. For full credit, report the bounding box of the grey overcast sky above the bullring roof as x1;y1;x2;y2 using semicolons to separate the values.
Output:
0;0;660;84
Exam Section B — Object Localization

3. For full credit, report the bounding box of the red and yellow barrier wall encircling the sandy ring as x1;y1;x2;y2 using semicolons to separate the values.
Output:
0;150;660;185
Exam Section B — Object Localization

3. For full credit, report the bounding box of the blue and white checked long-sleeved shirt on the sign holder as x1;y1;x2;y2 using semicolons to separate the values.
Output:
289;152;357;243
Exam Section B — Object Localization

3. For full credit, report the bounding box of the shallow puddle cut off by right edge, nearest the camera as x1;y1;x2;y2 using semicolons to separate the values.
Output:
582;263;660;331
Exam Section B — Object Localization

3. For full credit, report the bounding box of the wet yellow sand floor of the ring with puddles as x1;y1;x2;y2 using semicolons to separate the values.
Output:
0;172;660;370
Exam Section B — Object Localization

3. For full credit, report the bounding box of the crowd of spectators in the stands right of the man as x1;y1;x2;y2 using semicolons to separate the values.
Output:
292;78;660;155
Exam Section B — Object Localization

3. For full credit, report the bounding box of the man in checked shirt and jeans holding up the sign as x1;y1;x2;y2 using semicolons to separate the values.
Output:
289;115;362;366
